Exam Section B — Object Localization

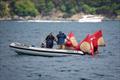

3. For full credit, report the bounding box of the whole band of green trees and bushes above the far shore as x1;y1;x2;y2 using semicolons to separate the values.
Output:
0;0;120;17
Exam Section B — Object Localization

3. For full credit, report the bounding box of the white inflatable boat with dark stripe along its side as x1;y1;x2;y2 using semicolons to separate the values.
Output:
9;42;84;56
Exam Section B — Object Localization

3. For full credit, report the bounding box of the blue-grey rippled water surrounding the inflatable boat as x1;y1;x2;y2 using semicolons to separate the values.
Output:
0;21;120;80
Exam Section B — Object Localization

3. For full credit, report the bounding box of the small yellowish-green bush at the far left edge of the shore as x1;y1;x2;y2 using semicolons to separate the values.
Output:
0;1;9;17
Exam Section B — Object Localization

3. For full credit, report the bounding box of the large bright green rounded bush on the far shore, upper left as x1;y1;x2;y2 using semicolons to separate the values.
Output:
14;0;38;16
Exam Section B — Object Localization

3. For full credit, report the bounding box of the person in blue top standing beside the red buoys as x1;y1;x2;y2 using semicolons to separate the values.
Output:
56;31;66;49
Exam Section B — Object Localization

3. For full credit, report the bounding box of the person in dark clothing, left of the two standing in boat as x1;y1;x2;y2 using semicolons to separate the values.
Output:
45;33;56;48
